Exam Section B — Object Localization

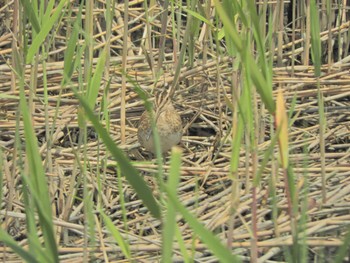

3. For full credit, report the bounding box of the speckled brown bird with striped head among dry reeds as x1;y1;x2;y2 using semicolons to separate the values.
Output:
137;89;182;155
